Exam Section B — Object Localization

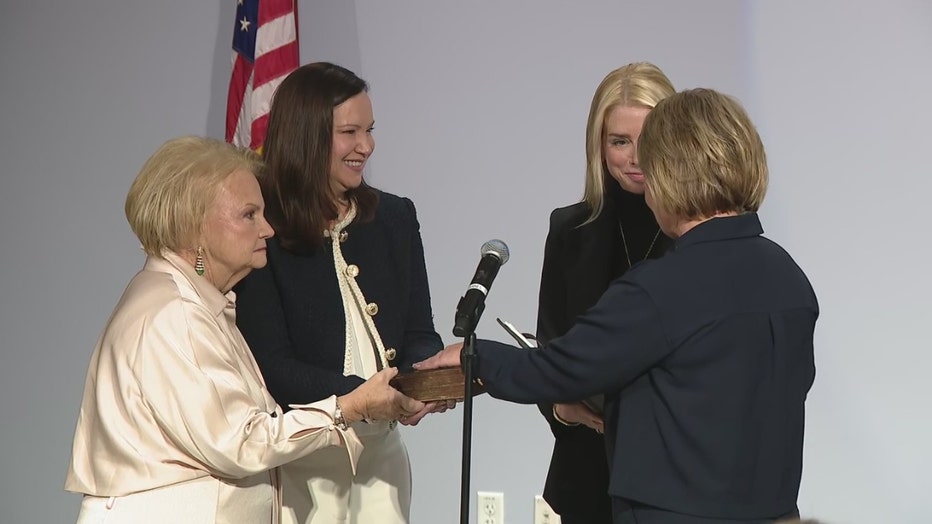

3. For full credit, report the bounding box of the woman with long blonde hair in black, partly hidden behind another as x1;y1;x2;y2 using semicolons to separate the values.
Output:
537;62;675;524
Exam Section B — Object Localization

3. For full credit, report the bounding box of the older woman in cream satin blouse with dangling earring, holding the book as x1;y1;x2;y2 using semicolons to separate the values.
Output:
65;137;424;524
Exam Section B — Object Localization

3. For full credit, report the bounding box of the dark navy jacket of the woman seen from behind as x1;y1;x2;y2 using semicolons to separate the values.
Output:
476;213;819;522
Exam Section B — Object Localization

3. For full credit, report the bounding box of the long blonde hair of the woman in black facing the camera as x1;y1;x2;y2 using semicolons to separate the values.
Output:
583;62;676;222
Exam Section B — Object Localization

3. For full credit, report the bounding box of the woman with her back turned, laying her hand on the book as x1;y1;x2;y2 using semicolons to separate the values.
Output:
416;89;819;524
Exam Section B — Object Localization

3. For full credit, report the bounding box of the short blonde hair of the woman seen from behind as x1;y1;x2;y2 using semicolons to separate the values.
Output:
638;89;767;219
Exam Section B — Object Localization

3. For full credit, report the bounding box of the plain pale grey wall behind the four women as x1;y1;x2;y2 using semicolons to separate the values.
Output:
0;0;932;524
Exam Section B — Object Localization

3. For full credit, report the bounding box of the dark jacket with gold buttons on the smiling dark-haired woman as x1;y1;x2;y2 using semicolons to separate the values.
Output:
234;192;443;409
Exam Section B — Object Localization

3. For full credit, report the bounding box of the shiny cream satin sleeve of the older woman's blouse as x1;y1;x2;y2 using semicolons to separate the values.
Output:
131;294;362;478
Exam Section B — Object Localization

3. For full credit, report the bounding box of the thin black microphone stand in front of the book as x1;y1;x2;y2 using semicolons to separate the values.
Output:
453;297;485;524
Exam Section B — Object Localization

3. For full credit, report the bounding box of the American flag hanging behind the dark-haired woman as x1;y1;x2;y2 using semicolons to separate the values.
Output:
226;0;298;150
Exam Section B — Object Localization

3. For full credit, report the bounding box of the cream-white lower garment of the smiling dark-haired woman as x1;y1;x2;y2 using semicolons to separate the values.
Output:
282;422;411;524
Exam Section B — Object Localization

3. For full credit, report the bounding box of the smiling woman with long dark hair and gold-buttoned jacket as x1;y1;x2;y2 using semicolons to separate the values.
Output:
236;62;449;524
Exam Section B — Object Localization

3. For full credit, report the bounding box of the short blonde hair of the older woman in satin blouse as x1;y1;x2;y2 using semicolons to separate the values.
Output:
125;136;262;256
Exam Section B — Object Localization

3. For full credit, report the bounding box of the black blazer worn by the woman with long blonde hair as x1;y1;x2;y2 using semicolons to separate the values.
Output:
537;188;672;524
